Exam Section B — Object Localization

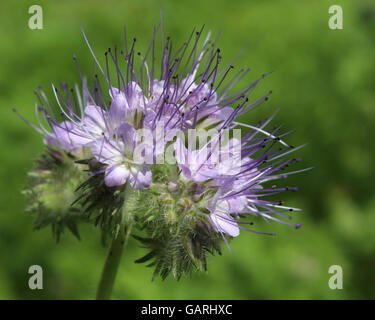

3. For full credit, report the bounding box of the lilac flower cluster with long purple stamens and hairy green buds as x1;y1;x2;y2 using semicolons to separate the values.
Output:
18;20;303;277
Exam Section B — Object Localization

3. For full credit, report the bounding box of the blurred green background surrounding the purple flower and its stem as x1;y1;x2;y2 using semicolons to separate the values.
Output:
0;0;375;299
